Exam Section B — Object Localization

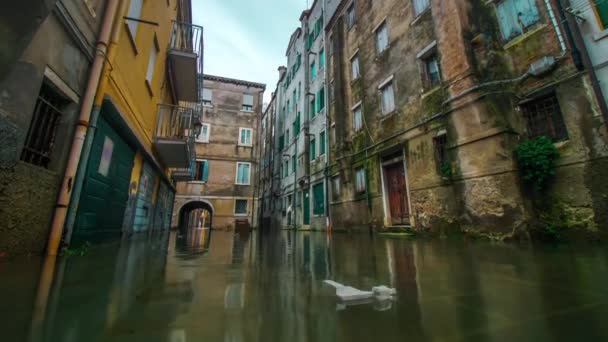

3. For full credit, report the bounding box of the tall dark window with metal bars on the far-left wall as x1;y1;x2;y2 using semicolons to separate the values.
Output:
21;82;70;168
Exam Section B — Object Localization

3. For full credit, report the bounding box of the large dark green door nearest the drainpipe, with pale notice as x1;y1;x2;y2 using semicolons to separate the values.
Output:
74;116;135;241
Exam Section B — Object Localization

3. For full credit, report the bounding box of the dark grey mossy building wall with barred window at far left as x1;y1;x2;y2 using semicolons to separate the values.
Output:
0;0;106;254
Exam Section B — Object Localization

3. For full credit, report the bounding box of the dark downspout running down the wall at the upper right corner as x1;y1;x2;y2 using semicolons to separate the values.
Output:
556;0;608;124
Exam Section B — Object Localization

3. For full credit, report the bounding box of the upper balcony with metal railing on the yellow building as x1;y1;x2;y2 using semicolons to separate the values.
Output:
167;21;203;102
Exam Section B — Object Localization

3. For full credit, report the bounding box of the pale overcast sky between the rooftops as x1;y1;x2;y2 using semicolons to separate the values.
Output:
192;0;312;102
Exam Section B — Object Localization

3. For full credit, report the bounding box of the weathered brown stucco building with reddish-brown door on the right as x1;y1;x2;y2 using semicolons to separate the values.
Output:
326;0;608;238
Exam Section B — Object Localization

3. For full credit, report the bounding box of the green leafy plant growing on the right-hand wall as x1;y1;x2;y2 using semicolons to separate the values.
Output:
515;136;559;190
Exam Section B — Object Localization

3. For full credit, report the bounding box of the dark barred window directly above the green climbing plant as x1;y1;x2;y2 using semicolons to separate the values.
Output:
521;93;568;142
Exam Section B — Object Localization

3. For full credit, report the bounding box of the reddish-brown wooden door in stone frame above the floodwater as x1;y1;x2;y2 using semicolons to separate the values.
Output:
384;163;409;224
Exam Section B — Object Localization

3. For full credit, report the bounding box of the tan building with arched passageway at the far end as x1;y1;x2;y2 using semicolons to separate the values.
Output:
173;75;266;230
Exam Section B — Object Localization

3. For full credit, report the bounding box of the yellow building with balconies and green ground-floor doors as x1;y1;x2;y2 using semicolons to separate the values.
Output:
58;0;203;243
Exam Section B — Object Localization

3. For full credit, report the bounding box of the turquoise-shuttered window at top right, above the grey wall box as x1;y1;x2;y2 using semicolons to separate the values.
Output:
496;0;540;41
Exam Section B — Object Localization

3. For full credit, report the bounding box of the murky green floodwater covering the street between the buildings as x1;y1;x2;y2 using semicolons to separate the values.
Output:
0;230;608;342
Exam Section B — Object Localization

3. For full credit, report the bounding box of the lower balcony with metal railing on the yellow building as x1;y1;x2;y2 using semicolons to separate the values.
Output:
153;104;200;169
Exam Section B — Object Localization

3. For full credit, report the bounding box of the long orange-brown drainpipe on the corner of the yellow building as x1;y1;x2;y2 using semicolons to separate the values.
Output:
47;0;121;256
